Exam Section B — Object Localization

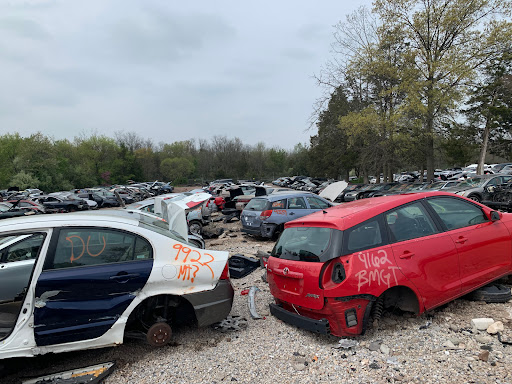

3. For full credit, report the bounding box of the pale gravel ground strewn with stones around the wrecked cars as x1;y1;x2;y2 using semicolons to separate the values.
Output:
0;212;512;384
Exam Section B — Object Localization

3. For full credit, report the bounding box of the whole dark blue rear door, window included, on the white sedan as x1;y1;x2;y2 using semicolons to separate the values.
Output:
34;227;153;346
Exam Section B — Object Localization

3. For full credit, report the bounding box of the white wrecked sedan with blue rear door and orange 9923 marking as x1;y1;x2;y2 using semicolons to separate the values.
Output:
0;211;233;359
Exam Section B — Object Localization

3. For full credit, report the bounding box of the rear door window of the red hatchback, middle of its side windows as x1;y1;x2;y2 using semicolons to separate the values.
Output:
386;203;437;241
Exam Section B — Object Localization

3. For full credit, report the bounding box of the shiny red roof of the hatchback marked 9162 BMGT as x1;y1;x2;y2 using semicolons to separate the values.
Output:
285;191;460;230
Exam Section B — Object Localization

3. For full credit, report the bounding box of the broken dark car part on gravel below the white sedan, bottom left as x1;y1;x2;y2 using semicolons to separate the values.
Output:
22;361;115;384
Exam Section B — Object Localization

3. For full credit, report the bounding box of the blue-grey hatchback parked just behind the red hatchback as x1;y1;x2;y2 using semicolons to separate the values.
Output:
240;191;333;238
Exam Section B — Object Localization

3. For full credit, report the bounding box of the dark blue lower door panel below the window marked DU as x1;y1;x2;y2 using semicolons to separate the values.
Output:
34;260;153;345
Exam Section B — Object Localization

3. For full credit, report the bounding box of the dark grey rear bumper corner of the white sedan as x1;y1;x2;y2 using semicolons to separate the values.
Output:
183;280;234;327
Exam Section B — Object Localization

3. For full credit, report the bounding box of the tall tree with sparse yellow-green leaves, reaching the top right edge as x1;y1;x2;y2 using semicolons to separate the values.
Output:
374;0;510;180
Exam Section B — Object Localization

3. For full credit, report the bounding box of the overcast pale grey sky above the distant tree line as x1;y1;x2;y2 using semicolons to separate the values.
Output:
0;0;371;149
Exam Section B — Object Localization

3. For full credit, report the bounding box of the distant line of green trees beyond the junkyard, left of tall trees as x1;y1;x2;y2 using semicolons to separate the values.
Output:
0;132;308;192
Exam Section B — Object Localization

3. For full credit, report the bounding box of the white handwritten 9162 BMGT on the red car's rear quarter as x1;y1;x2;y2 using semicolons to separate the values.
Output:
356;249;400;292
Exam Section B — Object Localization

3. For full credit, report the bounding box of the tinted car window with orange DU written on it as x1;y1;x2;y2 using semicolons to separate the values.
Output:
46;228;152;269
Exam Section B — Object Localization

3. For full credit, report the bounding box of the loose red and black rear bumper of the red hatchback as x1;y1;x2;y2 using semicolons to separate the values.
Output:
270;295;375;337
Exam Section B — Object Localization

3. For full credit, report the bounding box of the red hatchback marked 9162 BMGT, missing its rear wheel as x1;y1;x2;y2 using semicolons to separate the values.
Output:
267;192;512;336
